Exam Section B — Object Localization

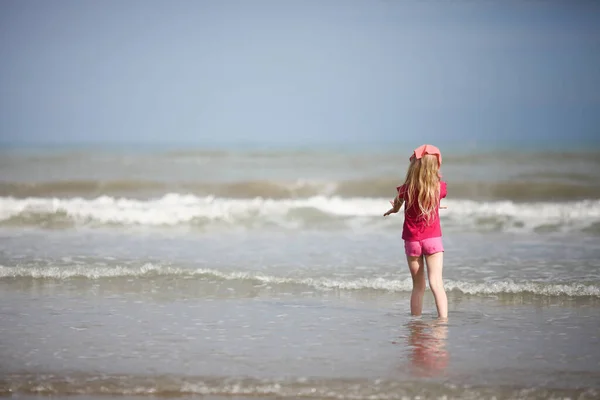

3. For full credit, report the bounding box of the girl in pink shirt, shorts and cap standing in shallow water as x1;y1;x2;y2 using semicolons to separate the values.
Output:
383;144;448;319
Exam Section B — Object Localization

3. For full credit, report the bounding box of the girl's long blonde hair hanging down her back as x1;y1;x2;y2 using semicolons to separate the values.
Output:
404;154;440;224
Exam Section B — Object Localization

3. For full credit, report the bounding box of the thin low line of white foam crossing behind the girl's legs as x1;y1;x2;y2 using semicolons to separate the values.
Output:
0;264;600;297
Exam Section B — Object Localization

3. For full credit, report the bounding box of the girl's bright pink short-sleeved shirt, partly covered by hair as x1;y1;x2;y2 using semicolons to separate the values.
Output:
396;181;448;242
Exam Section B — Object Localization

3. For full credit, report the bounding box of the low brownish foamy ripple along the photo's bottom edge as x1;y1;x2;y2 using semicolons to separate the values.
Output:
0;373;598;400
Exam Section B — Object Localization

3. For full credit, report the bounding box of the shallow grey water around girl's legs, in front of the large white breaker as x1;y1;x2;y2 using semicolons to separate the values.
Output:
0;230;600;398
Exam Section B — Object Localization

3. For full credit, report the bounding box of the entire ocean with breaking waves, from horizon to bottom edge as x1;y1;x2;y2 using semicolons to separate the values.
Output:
0;146;600;400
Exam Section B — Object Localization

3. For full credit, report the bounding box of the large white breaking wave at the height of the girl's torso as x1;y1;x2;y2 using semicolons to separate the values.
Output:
0;194;600;234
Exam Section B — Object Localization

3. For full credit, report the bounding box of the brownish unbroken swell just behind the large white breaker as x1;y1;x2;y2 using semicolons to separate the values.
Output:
0;178;600;202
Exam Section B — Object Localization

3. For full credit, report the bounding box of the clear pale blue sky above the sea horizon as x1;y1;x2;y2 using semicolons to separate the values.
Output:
0;0;600;148
